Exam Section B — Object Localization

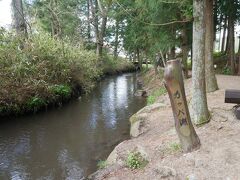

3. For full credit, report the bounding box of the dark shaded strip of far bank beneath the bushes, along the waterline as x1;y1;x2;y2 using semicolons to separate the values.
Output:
0;66;136;117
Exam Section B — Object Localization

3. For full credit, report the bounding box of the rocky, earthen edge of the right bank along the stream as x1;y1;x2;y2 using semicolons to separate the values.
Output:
86;68;165;180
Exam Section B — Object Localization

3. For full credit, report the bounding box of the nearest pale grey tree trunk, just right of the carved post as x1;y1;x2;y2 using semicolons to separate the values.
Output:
192;0;210;125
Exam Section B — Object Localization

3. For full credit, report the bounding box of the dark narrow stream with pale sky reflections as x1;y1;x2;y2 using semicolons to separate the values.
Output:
0;74;146;180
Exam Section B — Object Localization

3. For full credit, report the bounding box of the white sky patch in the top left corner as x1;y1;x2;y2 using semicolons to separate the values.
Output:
0;0;12;27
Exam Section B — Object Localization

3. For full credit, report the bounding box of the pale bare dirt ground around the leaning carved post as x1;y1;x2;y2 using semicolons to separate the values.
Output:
91;75;240;180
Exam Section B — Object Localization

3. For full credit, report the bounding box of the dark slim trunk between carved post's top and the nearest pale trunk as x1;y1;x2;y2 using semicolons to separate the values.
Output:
182;25;188;78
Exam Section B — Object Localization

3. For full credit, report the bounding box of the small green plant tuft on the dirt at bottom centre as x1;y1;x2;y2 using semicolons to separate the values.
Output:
126;152;148;169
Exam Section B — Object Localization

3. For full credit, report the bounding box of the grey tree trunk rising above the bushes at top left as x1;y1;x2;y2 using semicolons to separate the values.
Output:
12;0;27;37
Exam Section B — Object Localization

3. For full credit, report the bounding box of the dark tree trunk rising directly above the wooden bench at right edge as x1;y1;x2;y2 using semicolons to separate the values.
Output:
228;15;235;74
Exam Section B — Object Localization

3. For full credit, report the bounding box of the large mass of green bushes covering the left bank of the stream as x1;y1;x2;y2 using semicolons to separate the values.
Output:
0;29;102;112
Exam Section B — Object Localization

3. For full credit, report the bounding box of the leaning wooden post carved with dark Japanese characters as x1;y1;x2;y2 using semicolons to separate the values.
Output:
164;60;200;152
